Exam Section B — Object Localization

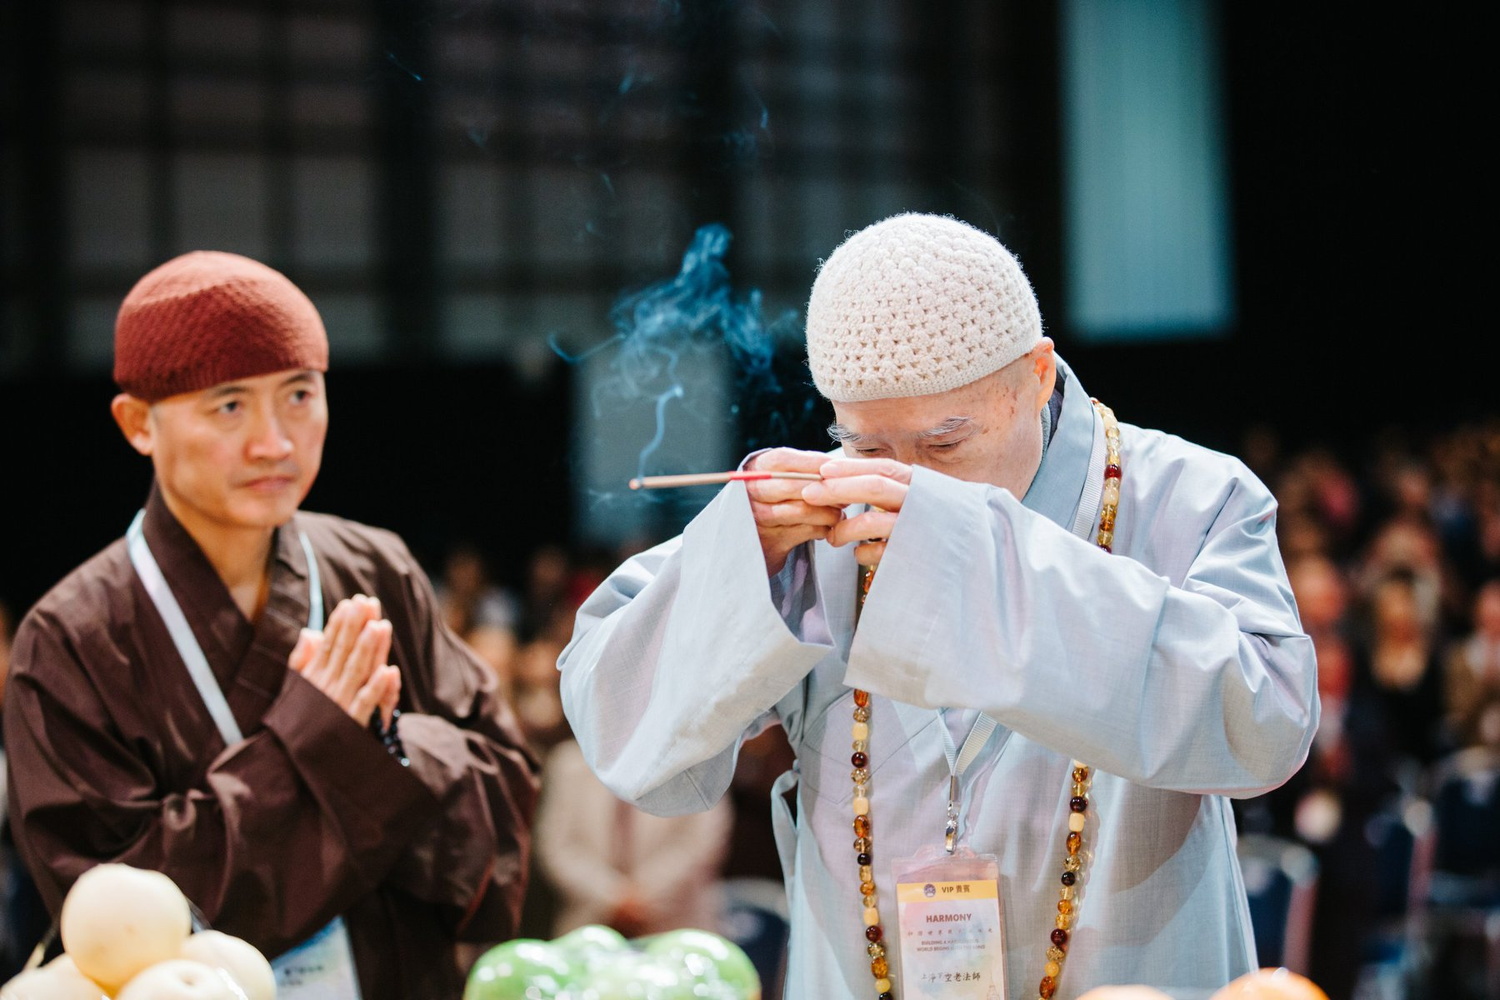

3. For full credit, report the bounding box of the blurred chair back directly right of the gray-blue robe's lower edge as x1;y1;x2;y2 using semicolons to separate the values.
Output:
1236;834;1319;976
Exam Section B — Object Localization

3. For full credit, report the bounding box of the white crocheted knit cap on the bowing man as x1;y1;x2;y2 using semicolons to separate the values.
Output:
807;213;1041;403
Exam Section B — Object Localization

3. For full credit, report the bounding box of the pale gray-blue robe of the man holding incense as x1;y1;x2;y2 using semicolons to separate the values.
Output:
560;355;1319;1000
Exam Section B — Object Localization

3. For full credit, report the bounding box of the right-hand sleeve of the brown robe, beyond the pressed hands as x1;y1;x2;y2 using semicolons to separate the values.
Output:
366;535;539;942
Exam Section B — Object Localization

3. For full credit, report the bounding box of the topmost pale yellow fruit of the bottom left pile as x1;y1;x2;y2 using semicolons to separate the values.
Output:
59;864;192;993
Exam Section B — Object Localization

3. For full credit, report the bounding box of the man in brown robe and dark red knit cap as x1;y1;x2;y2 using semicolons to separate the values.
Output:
5;252;537;1000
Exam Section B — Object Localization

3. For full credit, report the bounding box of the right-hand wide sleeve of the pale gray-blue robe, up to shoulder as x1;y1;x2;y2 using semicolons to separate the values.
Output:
846;453;1319;796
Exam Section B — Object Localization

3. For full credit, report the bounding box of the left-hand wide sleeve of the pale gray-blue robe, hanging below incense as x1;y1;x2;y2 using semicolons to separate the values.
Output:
558;483;834;816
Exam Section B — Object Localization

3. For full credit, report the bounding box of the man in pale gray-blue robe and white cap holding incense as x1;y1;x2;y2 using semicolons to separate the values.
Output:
560;214;1319;1000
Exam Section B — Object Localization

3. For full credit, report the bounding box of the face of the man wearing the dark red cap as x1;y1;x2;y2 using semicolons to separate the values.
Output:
116;370;329;535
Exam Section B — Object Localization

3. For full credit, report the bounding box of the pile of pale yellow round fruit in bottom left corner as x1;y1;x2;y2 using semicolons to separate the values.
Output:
0;865;276;1000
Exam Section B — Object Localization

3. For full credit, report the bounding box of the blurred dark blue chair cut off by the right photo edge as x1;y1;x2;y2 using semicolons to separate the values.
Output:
1412;747;1500;1000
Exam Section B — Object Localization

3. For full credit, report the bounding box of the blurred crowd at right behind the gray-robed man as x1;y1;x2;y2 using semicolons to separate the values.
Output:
1244;413;1500;787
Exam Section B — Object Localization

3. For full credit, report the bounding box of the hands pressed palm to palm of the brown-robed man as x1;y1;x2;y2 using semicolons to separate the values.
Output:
287;594;401;726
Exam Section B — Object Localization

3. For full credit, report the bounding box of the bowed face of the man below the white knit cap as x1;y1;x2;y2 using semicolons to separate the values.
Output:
831;337;1058;496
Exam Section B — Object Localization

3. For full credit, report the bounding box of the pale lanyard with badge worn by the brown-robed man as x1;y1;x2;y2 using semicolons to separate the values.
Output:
125;510;360;1000
